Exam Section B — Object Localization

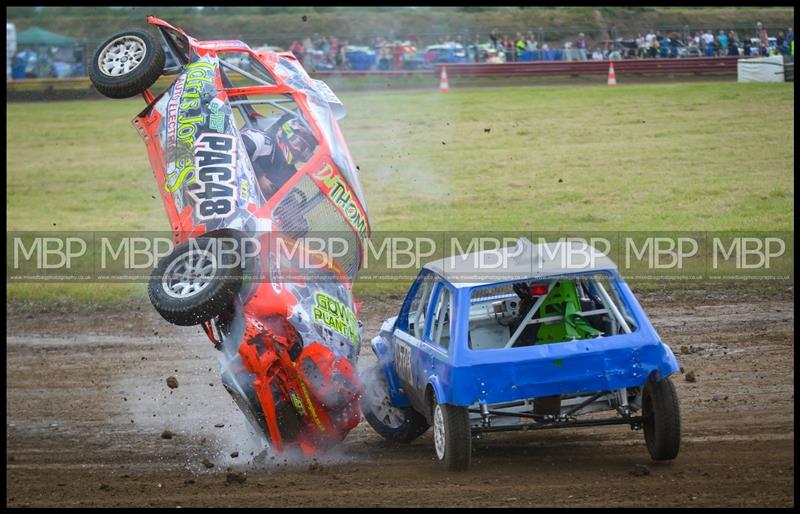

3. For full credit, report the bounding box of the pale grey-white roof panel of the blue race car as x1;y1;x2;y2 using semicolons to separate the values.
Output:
423;237;617;289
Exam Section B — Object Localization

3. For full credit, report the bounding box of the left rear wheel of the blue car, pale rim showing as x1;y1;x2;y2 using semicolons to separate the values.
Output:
432;395;472;471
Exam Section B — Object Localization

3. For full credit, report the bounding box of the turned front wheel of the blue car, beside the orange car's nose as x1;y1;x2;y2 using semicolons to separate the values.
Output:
359;364;430;443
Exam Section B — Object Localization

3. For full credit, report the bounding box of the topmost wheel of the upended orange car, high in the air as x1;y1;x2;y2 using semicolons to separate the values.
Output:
89;30;165;98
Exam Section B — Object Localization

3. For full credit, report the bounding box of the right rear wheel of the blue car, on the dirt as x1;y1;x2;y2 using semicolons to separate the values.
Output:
642;378;681;460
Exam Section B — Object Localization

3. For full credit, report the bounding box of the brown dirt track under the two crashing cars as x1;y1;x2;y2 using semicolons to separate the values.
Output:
6;287;794;507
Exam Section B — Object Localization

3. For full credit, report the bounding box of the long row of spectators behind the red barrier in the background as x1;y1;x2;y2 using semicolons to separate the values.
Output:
289;22;794;70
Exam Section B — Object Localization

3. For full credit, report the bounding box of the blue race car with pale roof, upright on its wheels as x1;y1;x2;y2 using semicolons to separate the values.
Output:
361;238;681;471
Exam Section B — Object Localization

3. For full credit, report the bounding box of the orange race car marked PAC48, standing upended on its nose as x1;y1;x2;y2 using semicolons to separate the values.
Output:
90;16;370;454
